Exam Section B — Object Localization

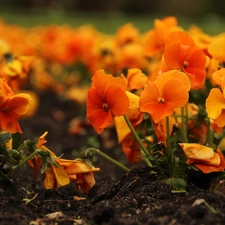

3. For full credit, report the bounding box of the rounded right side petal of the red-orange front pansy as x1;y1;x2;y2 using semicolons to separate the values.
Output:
105;85;129;116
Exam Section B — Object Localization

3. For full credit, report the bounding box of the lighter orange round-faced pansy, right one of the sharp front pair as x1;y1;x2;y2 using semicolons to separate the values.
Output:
139;71;189;123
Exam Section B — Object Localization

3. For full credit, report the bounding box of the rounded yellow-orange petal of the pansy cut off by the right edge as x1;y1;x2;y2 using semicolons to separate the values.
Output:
206;88;225;119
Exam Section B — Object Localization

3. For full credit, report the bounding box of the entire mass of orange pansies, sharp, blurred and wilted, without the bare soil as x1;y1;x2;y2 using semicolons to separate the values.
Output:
0;16;225;192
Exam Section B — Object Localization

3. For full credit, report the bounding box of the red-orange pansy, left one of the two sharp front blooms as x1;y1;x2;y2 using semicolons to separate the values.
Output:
86;70;129;133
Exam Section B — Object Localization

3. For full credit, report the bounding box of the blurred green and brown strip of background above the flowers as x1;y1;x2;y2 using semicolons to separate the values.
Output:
0;0;225;35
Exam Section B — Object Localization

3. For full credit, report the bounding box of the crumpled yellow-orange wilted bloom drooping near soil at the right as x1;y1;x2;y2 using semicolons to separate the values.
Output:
179;143;225;173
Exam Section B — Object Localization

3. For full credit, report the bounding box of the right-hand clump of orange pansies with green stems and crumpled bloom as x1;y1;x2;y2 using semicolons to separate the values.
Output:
86;17;225;189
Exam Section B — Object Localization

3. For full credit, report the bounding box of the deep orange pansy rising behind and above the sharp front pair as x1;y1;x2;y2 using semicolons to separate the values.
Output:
162;31;206;89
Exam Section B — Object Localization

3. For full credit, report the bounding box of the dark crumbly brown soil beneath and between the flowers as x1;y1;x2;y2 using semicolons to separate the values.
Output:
0;90;225;225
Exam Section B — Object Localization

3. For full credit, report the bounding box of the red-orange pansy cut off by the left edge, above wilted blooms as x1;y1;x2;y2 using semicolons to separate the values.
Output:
0;79;31;133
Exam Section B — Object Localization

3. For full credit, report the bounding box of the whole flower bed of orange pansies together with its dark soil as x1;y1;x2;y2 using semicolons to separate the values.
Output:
0;17;225;224
